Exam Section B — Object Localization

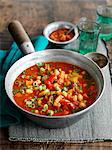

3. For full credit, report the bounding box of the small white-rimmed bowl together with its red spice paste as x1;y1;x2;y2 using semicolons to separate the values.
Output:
43;21;79;47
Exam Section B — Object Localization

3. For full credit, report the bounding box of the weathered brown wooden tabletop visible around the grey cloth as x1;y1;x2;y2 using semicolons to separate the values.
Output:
0;0;112;150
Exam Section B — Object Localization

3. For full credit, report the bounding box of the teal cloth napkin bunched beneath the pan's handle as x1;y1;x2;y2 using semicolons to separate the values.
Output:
0;36;48;127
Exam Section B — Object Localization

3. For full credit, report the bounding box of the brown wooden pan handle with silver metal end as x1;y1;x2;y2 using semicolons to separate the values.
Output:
8;20;35;54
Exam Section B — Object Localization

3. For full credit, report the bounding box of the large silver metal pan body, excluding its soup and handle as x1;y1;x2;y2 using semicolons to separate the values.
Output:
5;49;104;128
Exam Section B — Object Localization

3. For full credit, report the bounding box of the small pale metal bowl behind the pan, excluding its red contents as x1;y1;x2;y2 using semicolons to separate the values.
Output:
43;21;79;46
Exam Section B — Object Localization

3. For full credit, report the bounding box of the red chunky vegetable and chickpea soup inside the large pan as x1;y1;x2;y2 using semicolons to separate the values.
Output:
13;62;97;116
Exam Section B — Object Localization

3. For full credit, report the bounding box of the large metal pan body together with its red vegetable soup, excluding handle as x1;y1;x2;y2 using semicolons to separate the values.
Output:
5;49;104;128
